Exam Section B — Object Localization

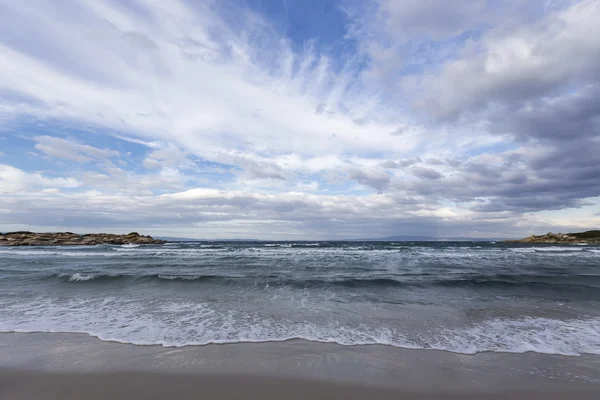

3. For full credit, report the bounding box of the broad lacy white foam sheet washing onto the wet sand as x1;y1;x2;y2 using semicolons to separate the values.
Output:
0;297;600;356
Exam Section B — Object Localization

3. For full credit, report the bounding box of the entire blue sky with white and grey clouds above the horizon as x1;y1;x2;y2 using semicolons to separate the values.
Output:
0;0;600;240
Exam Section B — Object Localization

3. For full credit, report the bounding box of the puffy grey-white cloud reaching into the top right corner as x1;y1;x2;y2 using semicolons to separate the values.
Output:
418;0;600;118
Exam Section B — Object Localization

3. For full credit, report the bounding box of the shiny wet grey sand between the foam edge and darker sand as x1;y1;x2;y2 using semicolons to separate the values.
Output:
0;333;600;394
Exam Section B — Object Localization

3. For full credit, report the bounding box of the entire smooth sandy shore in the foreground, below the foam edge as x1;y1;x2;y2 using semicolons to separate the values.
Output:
0;333;600;400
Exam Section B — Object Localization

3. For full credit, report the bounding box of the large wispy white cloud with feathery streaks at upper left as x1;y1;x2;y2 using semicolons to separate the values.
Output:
0;1;426;177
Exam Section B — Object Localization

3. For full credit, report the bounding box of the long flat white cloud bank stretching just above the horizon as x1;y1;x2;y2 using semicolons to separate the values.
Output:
0;175;600;239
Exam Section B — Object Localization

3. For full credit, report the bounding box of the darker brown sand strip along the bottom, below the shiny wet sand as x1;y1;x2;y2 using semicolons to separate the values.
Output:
0;370;599;400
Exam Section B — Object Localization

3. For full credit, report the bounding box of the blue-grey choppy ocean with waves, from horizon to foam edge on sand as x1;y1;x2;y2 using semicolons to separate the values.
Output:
0;242;600;356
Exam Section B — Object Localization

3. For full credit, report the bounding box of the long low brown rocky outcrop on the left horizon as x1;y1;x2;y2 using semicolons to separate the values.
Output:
0;231;166;246
